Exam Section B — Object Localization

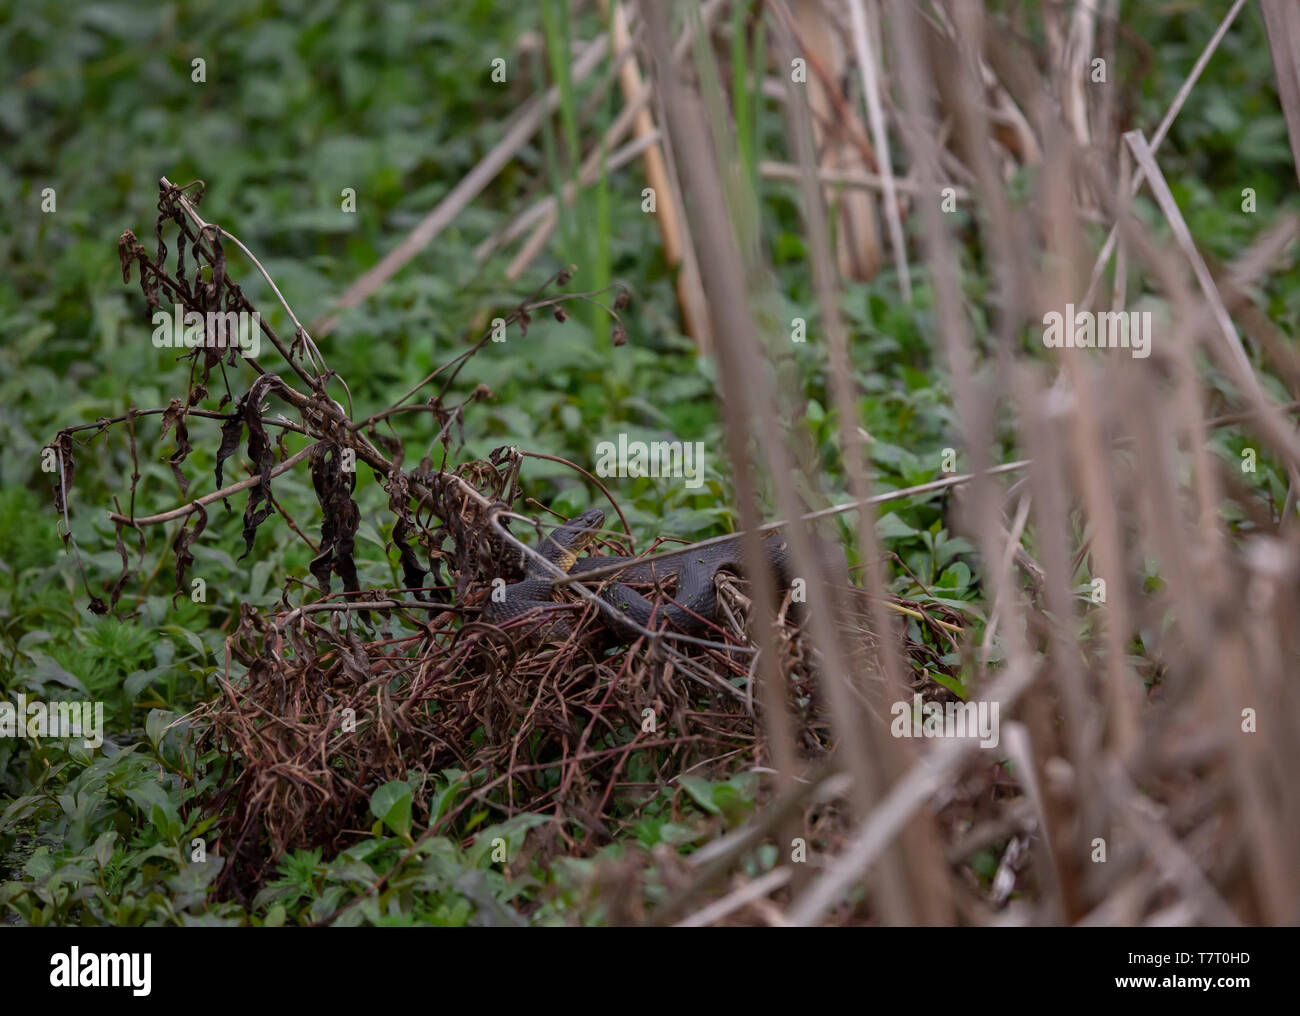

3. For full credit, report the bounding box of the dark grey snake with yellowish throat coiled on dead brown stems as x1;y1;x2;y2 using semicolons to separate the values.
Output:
484;508;811;638
